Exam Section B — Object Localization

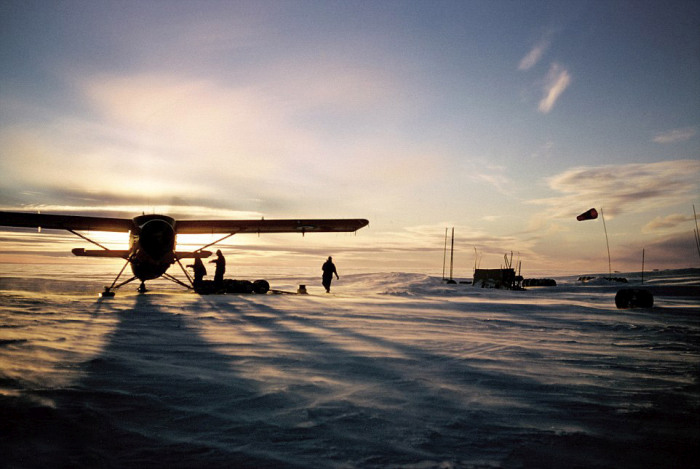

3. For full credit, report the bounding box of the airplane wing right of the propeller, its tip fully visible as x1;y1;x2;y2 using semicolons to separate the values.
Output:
175;218;369;234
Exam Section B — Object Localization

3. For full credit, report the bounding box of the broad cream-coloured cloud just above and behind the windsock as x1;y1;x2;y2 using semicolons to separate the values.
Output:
531;160;700;218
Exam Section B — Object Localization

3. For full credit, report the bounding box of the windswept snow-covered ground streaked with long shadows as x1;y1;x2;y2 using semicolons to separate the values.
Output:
0;269;700;469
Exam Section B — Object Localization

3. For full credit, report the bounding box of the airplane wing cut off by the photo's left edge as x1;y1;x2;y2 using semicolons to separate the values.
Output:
0;212;134;232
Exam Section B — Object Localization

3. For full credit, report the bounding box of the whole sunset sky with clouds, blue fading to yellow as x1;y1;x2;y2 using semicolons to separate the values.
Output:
0;0;700;277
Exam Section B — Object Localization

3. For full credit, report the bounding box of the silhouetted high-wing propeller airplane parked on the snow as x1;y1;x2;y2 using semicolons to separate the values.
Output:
0;211;369;297
